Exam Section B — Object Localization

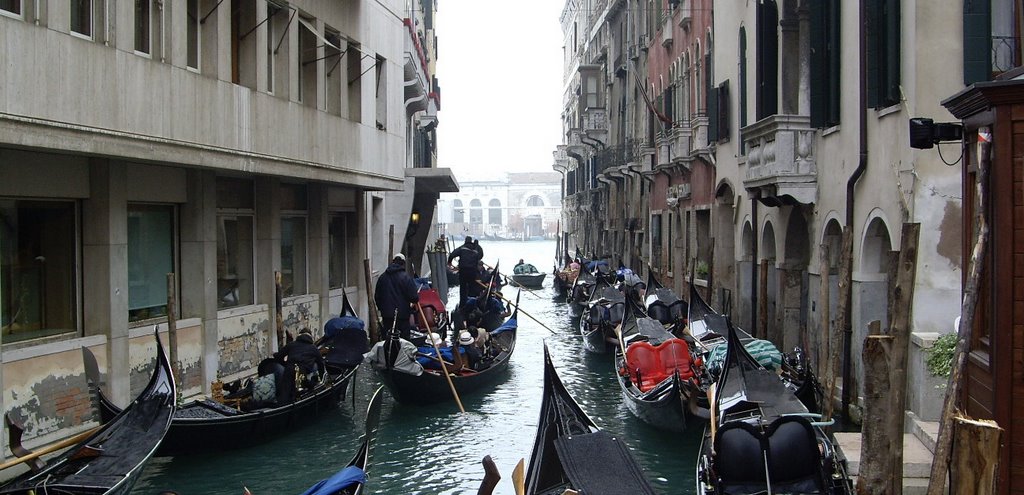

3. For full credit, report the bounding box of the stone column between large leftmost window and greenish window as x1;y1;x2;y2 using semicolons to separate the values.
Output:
82;159;131;406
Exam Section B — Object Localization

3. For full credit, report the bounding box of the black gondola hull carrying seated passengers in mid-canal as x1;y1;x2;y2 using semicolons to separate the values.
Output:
371;297;519;405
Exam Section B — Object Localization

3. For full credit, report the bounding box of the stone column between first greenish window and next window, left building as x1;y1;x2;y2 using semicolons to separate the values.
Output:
178;169;220;394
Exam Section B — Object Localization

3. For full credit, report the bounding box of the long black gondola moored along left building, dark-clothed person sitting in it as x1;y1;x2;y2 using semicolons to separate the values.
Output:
89;297;361;456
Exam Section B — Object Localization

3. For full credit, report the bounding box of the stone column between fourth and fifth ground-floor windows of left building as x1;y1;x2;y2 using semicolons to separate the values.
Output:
306;183;331;325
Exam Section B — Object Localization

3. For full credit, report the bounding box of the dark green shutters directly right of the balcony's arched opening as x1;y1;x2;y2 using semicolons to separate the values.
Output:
810;0;841;128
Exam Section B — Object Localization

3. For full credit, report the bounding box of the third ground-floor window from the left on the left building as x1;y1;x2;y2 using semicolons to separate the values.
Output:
217;177;256;307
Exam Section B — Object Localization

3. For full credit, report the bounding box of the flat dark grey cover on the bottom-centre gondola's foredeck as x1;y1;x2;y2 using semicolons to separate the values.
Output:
555;430;655;495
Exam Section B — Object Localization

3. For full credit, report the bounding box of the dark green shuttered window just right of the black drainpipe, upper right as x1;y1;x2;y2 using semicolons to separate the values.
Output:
865;0;900;109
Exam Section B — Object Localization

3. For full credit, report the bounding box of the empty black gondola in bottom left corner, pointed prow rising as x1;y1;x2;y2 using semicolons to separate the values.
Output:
0;337;177;495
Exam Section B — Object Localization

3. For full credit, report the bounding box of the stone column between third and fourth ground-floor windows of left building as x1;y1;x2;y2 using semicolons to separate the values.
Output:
253;175;281;353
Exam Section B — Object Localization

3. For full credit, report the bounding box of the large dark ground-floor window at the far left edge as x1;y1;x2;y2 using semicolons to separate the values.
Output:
0;201;79;343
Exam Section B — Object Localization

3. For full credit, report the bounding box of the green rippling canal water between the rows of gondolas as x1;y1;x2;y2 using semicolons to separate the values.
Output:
133;241;703;495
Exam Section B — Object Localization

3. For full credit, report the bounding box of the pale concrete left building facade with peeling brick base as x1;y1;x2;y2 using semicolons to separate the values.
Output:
0;0;455;448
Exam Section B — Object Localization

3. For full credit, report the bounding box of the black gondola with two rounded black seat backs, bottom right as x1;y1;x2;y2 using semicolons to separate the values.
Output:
696;319;853;495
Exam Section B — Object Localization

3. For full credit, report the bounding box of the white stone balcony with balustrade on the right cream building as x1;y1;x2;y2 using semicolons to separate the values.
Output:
739;115;818;204
